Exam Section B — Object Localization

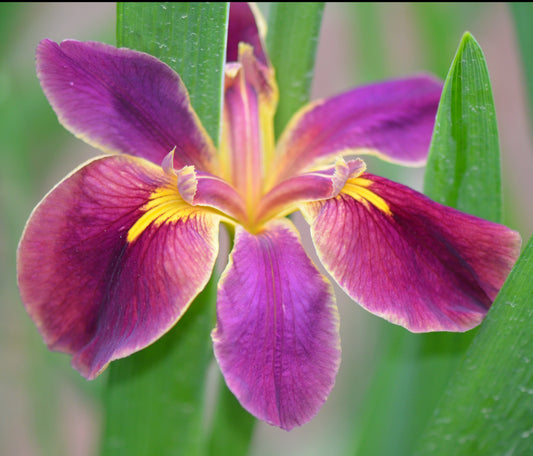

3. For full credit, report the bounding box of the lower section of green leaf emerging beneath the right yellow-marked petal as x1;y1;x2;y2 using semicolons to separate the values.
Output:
352;321;474;456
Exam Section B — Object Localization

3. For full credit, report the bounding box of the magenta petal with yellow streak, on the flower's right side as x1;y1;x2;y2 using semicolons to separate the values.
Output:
303;174;521;332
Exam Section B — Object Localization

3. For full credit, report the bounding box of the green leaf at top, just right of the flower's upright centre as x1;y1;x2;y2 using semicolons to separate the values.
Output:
266;2;324;137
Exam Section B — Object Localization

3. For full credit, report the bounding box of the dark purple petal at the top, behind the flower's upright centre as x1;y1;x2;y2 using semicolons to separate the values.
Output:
226;2;269;66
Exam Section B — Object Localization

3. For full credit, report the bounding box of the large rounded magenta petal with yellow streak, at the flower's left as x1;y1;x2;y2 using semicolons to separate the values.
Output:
17;155;218;379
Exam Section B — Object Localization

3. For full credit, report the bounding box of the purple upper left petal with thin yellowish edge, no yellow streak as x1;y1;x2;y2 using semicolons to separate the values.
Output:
37;40;216;171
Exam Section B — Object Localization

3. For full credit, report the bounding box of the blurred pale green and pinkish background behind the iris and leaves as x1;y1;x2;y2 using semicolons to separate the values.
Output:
0;3;533;456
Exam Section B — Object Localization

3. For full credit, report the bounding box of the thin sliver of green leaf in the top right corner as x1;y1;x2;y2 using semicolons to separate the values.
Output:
510;2;533;126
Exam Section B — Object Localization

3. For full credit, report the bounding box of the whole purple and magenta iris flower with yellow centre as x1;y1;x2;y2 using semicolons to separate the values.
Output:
18;3;520;430
